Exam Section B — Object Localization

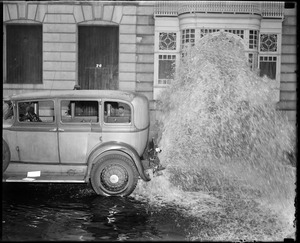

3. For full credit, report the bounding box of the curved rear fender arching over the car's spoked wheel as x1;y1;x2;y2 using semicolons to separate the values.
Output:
85;141;151;181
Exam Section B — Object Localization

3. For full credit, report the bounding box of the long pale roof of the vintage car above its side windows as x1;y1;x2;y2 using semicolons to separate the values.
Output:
9;90;144;101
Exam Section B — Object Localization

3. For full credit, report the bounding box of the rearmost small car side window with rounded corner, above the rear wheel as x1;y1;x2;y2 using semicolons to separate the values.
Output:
104;101;131;123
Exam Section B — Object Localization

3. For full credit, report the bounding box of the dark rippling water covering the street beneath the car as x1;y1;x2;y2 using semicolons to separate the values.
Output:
2;183;185;241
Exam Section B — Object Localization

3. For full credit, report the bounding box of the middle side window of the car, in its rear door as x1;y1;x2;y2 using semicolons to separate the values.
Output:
60;100;99;123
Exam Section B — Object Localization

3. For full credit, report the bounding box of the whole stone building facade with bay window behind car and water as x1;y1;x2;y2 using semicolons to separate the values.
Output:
3;1;297;135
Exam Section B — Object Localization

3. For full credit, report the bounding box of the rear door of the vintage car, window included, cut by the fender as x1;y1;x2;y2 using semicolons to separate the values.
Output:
58;99;101;165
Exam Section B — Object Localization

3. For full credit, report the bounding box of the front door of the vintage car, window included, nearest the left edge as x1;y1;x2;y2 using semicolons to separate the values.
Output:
11;99;59;164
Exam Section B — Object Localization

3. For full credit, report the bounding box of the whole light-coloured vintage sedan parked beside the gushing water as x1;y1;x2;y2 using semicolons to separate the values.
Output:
2;90;163;196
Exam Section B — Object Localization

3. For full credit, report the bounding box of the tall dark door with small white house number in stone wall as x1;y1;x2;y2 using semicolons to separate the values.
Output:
78;26;119;89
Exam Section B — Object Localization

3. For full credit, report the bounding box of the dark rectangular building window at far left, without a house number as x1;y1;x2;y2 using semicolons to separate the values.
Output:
6;25;42;84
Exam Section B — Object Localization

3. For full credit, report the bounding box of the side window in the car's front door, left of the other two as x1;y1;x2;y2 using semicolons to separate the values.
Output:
18;100;55;123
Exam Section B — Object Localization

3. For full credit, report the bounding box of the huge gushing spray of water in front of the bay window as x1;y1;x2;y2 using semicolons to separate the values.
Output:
134;34;296;240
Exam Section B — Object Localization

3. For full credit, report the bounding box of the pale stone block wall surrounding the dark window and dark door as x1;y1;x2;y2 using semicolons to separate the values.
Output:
3;1;146;98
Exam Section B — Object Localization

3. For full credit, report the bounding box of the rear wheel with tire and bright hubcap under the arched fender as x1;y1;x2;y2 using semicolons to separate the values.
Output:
91;154;138;196
